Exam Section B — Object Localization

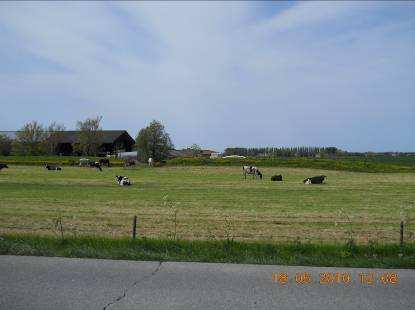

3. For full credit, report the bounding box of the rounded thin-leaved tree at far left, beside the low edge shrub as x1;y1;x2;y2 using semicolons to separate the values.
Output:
14;121;46;155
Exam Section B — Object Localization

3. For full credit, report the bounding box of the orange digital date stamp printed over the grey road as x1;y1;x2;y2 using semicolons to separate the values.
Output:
272;272;399;285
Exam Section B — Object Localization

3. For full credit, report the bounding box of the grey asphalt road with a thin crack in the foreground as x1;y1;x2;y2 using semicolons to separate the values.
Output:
0;256;415;310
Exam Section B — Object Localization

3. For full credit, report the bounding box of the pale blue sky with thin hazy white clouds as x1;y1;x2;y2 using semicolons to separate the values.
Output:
0;1;415;151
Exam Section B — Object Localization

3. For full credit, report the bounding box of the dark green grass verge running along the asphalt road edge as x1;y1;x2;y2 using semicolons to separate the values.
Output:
0;234;415;268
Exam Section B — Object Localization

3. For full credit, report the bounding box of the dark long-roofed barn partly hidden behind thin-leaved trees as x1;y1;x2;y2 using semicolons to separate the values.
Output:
0;130;135;155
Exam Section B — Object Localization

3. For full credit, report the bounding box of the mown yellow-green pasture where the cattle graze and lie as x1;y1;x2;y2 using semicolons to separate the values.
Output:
0;165;415;244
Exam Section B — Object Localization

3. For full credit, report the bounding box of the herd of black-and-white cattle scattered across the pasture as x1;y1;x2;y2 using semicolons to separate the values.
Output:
0;158;326;186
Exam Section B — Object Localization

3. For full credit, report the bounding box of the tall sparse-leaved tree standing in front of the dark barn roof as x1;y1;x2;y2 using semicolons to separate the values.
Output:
75;116;102;156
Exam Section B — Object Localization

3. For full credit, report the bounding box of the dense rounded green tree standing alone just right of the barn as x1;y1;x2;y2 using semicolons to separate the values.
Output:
136;120;174;161
